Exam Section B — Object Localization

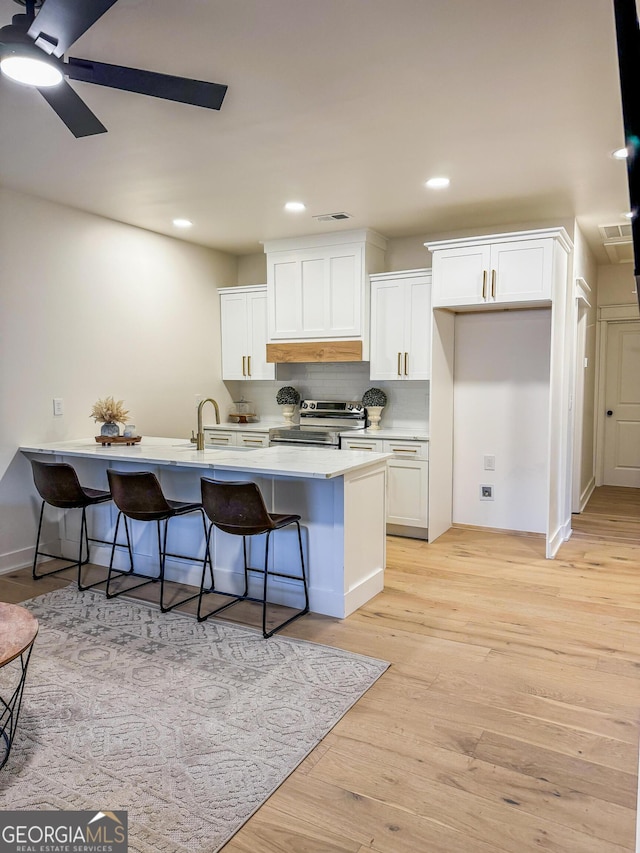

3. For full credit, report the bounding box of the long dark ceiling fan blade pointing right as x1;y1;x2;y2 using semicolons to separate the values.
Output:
67;56;227;110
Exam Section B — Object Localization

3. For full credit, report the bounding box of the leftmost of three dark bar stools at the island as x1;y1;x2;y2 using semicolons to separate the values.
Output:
31;459;111;590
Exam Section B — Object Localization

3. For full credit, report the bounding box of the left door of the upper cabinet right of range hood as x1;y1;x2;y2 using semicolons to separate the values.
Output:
369;279;404;379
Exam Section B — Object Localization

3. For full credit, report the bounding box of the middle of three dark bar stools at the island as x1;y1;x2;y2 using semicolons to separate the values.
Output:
106;468;213;613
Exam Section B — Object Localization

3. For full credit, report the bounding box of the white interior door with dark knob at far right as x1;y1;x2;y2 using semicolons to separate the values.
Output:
603;322;640;488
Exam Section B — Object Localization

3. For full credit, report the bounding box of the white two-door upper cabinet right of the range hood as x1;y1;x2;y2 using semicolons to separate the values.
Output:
370;270;431;380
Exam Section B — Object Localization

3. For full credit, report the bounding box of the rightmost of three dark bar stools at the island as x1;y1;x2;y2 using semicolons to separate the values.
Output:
198;477;309;638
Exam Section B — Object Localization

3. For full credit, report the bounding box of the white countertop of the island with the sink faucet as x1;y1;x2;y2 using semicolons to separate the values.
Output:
20;436;391;479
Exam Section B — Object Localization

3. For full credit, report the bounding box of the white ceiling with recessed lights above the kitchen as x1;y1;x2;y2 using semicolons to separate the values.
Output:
0;0;629;263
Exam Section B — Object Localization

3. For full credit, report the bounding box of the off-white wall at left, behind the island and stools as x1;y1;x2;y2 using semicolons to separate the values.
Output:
0;189;236;570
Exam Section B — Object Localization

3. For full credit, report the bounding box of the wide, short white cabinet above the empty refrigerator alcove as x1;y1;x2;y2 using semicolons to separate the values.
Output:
425;228;571;309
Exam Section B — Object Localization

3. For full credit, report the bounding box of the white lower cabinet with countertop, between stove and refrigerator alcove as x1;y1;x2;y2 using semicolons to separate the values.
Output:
341;436;429;539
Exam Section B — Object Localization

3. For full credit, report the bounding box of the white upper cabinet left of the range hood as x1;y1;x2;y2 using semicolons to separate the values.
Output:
218;285;275;379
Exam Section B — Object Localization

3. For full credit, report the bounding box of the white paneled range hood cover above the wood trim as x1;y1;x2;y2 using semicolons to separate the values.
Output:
265;230;386;352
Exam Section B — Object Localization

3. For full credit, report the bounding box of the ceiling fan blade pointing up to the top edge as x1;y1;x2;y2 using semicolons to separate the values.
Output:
27;0;117;56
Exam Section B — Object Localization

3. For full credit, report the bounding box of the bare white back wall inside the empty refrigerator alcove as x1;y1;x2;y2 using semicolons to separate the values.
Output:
453;309;551;533
